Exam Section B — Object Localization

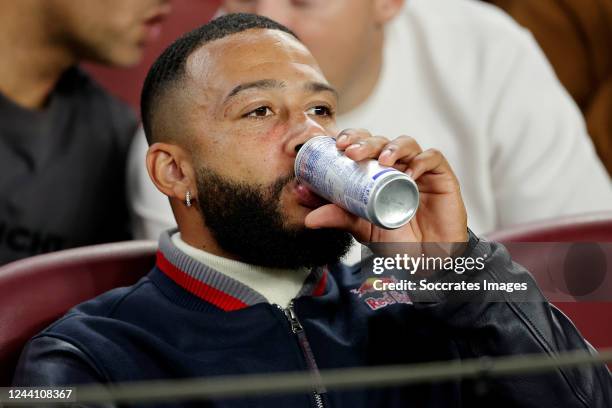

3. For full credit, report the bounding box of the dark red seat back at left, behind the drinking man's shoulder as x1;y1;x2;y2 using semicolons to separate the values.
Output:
0;241;157;386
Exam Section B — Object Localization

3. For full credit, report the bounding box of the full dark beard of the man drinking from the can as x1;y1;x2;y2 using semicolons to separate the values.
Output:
197;167;352;268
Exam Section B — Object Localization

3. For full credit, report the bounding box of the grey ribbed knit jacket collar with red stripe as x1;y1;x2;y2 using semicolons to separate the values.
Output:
156;230;328;311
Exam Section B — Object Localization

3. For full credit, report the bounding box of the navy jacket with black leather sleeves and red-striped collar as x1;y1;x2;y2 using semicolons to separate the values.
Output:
15;234;612;408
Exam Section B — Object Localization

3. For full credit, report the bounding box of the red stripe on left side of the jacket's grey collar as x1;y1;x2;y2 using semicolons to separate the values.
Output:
157;251;247;312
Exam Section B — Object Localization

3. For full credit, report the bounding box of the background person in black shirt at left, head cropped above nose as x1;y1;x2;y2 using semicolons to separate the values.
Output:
0;0;170;264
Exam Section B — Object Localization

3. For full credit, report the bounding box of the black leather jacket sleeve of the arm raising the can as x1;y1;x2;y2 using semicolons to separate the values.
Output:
411;232;612;408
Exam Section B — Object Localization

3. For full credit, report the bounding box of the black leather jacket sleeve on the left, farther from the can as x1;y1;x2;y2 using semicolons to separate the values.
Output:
13;336;116;408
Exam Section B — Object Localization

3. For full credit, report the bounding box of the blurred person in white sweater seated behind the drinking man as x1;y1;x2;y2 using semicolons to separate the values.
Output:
128;0;612;260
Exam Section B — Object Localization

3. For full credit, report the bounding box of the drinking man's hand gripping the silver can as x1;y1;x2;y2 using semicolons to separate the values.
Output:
305;129;468;244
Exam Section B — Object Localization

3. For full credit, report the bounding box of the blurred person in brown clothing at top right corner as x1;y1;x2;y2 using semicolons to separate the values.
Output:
488;0;612;174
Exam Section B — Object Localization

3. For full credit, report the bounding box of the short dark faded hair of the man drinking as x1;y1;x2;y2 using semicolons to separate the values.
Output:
140;13;299;144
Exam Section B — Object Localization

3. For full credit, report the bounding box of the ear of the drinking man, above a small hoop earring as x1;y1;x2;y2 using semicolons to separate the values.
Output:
147;143;197;201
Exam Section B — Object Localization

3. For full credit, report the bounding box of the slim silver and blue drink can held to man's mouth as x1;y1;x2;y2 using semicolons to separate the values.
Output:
295;136;419;229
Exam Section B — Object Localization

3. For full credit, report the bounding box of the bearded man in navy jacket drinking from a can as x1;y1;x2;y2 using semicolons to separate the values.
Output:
15;14;611;407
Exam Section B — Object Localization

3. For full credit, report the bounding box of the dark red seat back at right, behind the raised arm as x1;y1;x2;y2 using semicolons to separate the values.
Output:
487;212;612;368
